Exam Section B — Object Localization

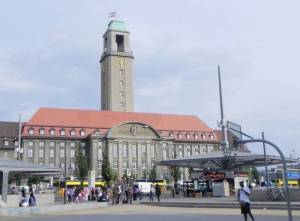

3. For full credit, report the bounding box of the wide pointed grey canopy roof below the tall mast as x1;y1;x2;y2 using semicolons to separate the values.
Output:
158;151;295;170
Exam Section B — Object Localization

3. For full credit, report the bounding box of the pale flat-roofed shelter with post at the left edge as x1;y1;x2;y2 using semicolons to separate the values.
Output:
0;158;62;202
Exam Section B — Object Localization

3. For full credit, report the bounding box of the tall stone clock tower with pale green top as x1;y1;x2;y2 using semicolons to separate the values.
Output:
100;20;134;112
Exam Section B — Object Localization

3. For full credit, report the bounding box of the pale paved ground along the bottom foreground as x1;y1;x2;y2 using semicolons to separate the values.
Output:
0;204;300;221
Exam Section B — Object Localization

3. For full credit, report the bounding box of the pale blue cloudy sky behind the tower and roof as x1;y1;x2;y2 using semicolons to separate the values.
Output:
0;0;300;157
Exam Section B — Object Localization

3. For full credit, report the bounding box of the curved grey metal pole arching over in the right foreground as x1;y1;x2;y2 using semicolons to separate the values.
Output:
239;139;293;221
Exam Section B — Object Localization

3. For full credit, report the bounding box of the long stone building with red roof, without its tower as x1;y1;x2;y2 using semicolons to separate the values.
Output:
22;108;219;179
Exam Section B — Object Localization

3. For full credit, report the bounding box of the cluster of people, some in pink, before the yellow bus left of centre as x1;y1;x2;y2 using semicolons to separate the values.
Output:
66;187;108;203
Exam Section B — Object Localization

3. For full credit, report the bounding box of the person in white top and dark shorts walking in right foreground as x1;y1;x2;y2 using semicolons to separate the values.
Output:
238;181;254;221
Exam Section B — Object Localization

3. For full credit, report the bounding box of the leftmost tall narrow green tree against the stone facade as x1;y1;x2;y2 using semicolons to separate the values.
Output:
75;146;89;186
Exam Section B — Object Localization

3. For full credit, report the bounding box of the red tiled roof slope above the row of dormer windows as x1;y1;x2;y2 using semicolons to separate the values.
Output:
26;108;213;132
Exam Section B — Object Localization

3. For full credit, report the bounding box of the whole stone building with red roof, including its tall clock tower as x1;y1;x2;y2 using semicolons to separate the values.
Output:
0;21;220;179
